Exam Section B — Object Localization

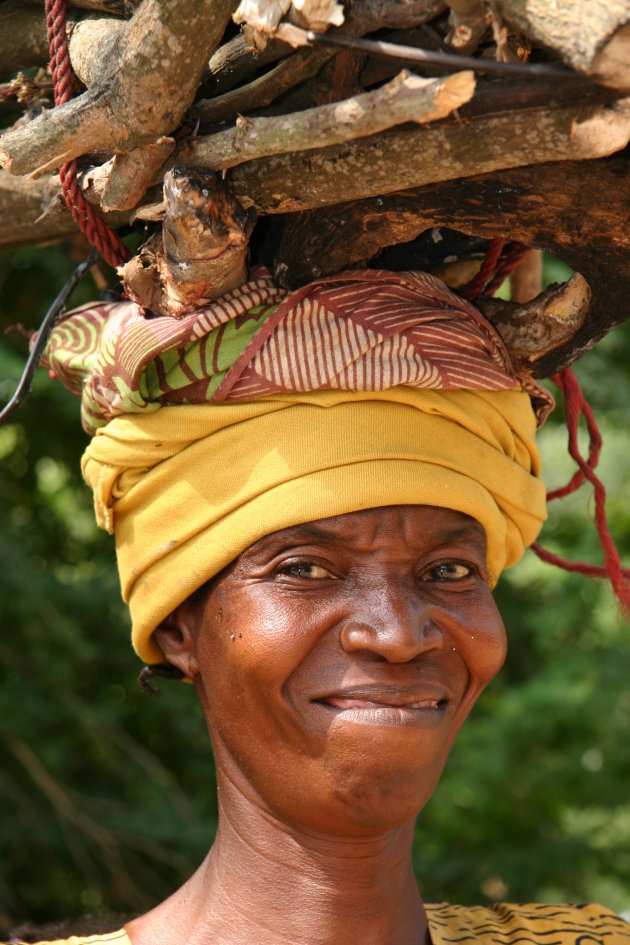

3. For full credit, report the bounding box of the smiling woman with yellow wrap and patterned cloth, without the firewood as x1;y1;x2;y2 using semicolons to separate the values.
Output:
14;271;630;945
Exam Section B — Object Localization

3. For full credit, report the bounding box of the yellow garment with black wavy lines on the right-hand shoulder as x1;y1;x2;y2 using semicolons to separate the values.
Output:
426;902;630;945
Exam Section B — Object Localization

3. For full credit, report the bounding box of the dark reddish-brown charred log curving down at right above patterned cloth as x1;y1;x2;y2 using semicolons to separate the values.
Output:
276;155;630;377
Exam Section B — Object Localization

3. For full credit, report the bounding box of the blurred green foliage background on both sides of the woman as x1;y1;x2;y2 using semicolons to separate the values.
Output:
0;248;630;935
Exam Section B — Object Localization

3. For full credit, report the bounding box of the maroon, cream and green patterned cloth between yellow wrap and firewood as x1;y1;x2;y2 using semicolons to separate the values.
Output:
43;269;553;433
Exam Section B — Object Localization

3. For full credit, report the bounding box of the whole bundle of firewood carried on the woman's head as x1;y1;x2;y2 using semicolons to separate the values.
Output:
0;0;630;376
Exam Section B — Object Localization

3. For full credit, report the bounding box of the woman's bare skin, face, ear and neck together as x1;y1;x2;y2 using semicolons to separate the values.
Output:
128;506;506;945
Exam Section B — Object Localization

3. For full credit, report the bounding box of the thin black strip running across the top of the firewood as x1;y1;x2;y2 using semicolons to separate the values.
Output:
306;30;578;78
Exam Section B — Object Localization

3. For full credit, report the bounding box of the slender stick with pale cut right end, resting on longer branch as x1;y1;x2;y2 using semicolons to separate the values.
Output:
188;70;475;170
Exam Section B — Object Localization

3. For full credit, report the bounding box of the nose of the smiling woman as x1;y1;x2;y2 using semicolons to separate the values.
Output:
340;586;444;663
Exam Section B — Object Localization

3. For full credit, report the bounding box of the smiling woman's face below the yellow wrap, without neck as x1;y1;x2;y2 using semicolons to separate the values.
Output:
163;506;506;834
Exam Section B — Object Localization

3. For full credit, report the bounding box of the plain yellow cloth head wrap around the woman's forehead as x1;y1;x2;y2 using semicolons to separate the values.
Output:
83;387;545;663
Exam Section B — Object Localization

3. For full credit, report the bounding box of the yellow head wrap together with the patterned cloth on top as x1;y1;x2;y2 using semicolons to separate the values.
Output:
46;270;553;662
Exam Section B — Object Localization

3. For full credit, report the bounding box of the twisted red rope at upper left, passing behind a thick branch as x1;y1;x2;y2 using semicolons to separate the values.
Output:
46;0;129;267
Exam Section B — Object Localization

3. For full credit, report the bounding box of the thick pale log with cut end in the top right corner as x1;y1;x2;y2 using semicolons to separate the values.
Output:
496;0;630;89
